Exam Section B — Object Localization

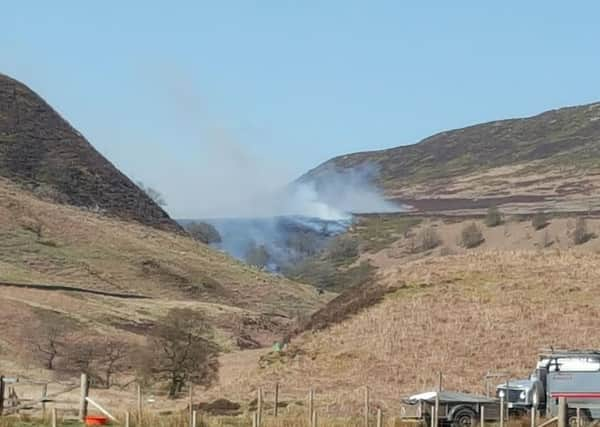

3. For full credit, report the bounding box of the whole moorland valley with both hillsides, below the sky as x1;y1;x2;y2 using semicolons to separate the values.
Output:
0;71;600;424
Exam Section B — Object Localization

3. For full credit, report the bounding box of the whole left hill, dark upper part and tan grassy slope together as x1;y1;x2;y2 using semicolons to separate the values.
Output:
0;75;330;373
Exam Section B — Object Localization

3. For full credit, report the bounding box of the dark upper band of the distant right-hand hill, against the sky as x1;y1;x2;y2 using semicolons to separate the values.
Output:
305;103;600;188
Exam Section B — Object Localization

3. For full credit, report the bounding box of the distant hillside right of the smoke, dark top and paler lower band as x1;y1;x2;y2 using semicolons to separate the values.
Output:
301;103;600;214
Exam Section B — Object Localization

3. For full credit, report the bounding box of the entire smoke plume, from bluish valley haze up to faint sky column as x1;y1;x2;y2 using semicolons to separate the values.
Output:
155;71;402;270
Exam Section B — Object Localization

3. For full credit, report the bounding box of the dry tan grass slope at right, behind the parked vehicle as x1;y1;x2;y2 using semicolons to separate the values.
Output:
207;250;600;413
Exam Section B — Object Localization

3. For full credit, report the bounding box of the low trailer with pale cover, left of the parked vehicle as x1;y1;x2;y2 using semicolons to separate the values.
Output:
401;391;500;427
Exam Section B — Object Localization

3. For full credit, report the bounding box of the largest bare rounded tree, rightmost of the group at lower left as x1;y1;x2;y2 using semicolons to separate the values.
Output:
143;308;219;398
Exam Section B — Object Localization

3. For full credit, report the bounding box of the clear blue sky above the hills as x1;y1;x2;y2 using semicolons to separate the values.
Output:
0;0;600;217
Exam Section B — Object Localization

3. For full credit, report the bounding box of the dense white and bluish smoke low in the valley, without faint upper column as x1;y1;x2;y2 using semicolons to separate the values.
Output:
189;165;401;271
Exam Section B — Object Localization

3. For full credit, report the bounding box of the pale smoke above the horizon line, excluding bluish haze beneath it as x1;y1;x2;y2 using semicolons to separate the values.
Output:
148;67;400;220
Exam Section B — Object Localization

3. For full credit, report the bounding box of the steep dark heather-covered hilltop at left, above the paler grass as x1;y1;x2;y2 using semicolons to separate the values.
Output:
0;74;181;231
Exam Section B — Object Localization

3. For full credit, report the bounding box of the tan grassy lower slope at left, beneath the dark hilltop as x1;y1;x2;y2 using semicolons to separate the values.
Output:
0;179;329;370
